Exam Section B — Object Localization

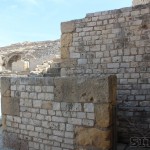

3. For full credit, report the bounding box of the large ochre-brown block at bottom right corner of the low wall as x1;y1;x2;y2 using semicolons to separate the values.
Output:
75;127;112;150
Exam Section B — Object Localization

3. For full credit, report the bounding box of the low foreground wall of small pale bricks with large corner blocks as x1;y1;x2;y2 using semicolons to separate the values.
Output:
1;76;116;150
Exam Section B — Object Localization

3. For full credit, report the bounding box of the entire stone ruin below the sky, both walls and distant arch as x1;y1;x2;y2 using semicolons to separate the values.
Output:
0;0;150;150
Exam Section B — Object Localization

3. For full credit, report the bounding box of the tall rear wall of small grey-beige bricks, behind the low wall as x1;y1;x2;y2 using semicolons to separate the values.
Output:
61;4;150;142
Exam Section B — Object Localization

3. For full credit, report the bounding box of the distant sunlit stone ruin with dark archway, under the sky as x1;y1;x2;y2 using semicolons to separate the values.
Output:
0;40;60;73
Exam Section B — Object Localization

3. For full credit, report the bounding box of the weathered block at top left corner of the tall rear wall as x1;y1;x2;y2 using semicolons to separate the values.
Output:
61;21;75;34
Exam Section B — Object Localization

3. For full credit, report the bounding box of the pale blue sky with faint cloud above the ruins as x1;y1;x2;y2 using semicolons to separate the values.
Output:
0;0;132;46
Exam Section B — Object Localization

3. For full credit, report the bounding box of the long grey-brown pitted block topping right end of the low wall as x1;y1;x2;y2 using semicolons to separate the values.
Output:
54;76;116;103
